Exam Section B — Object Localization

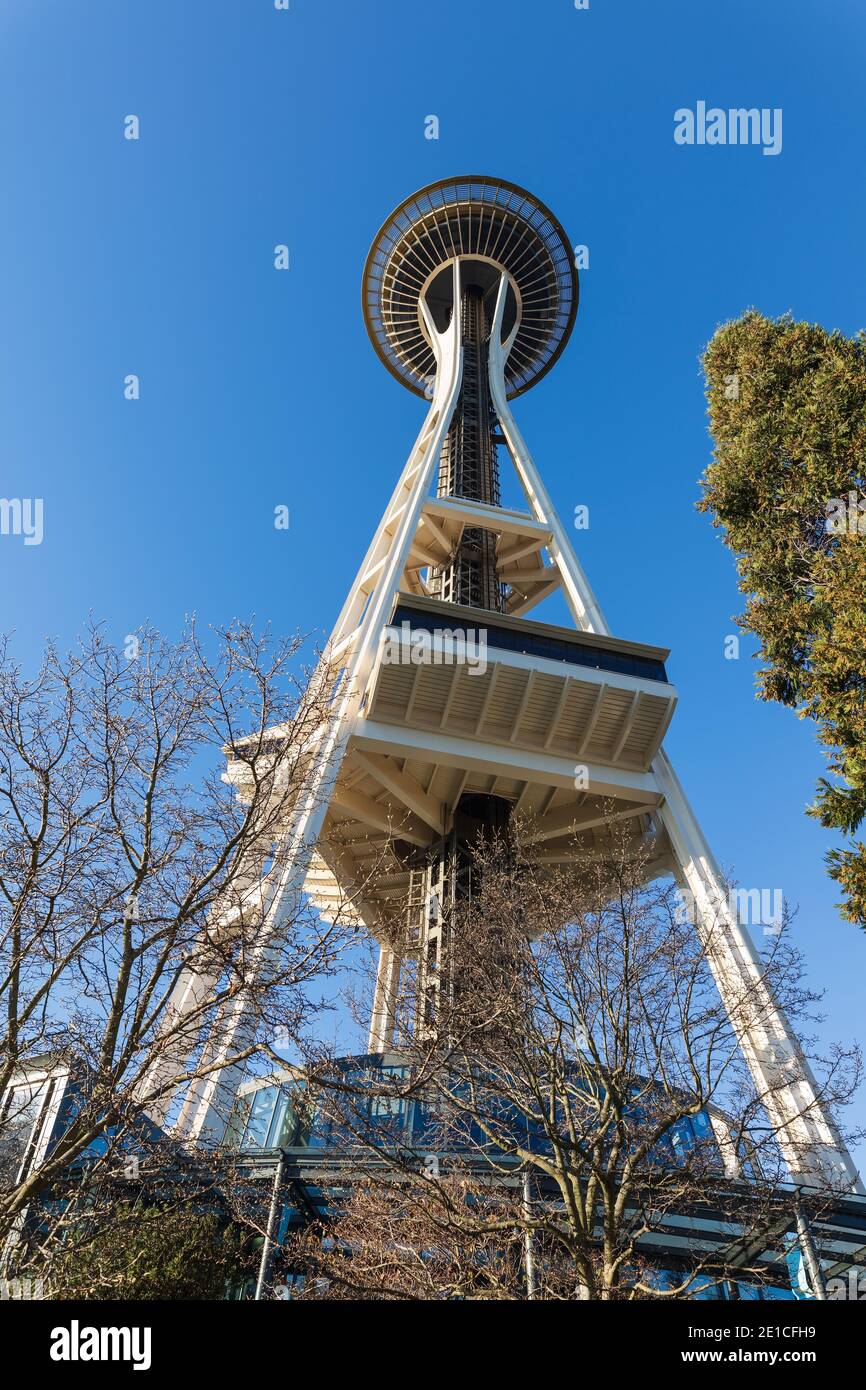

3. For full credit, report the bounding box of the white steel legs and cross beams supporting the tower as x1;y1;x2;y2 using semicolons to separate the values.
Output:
161;256;863;1191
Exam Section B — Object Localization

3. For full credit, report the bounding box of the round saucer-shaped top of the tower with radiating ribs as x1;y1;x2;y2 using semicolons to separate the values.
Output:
363;174;578;398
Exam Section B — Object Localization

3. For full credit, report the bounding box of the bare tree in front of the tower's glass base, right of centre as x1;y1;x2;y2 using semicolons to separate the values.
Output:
291;824;859;1300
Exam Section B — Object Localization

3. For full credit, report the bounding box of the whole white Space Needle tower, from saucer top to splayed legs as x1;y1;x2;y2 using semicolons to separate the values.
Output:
154;175;862;1191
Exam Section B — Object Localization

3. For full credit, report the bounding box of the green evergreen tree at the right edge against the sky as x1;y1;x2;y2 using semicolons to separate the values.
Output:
699;310;866;927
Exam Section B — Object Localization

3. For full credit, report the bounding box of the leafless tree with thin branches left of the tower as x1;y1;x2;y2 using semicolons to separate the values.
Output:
0;624;348;1234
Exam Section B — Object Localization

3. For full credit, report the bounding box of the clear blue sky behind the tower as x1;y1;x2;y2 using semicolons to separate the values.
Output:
0;0;866;1158
